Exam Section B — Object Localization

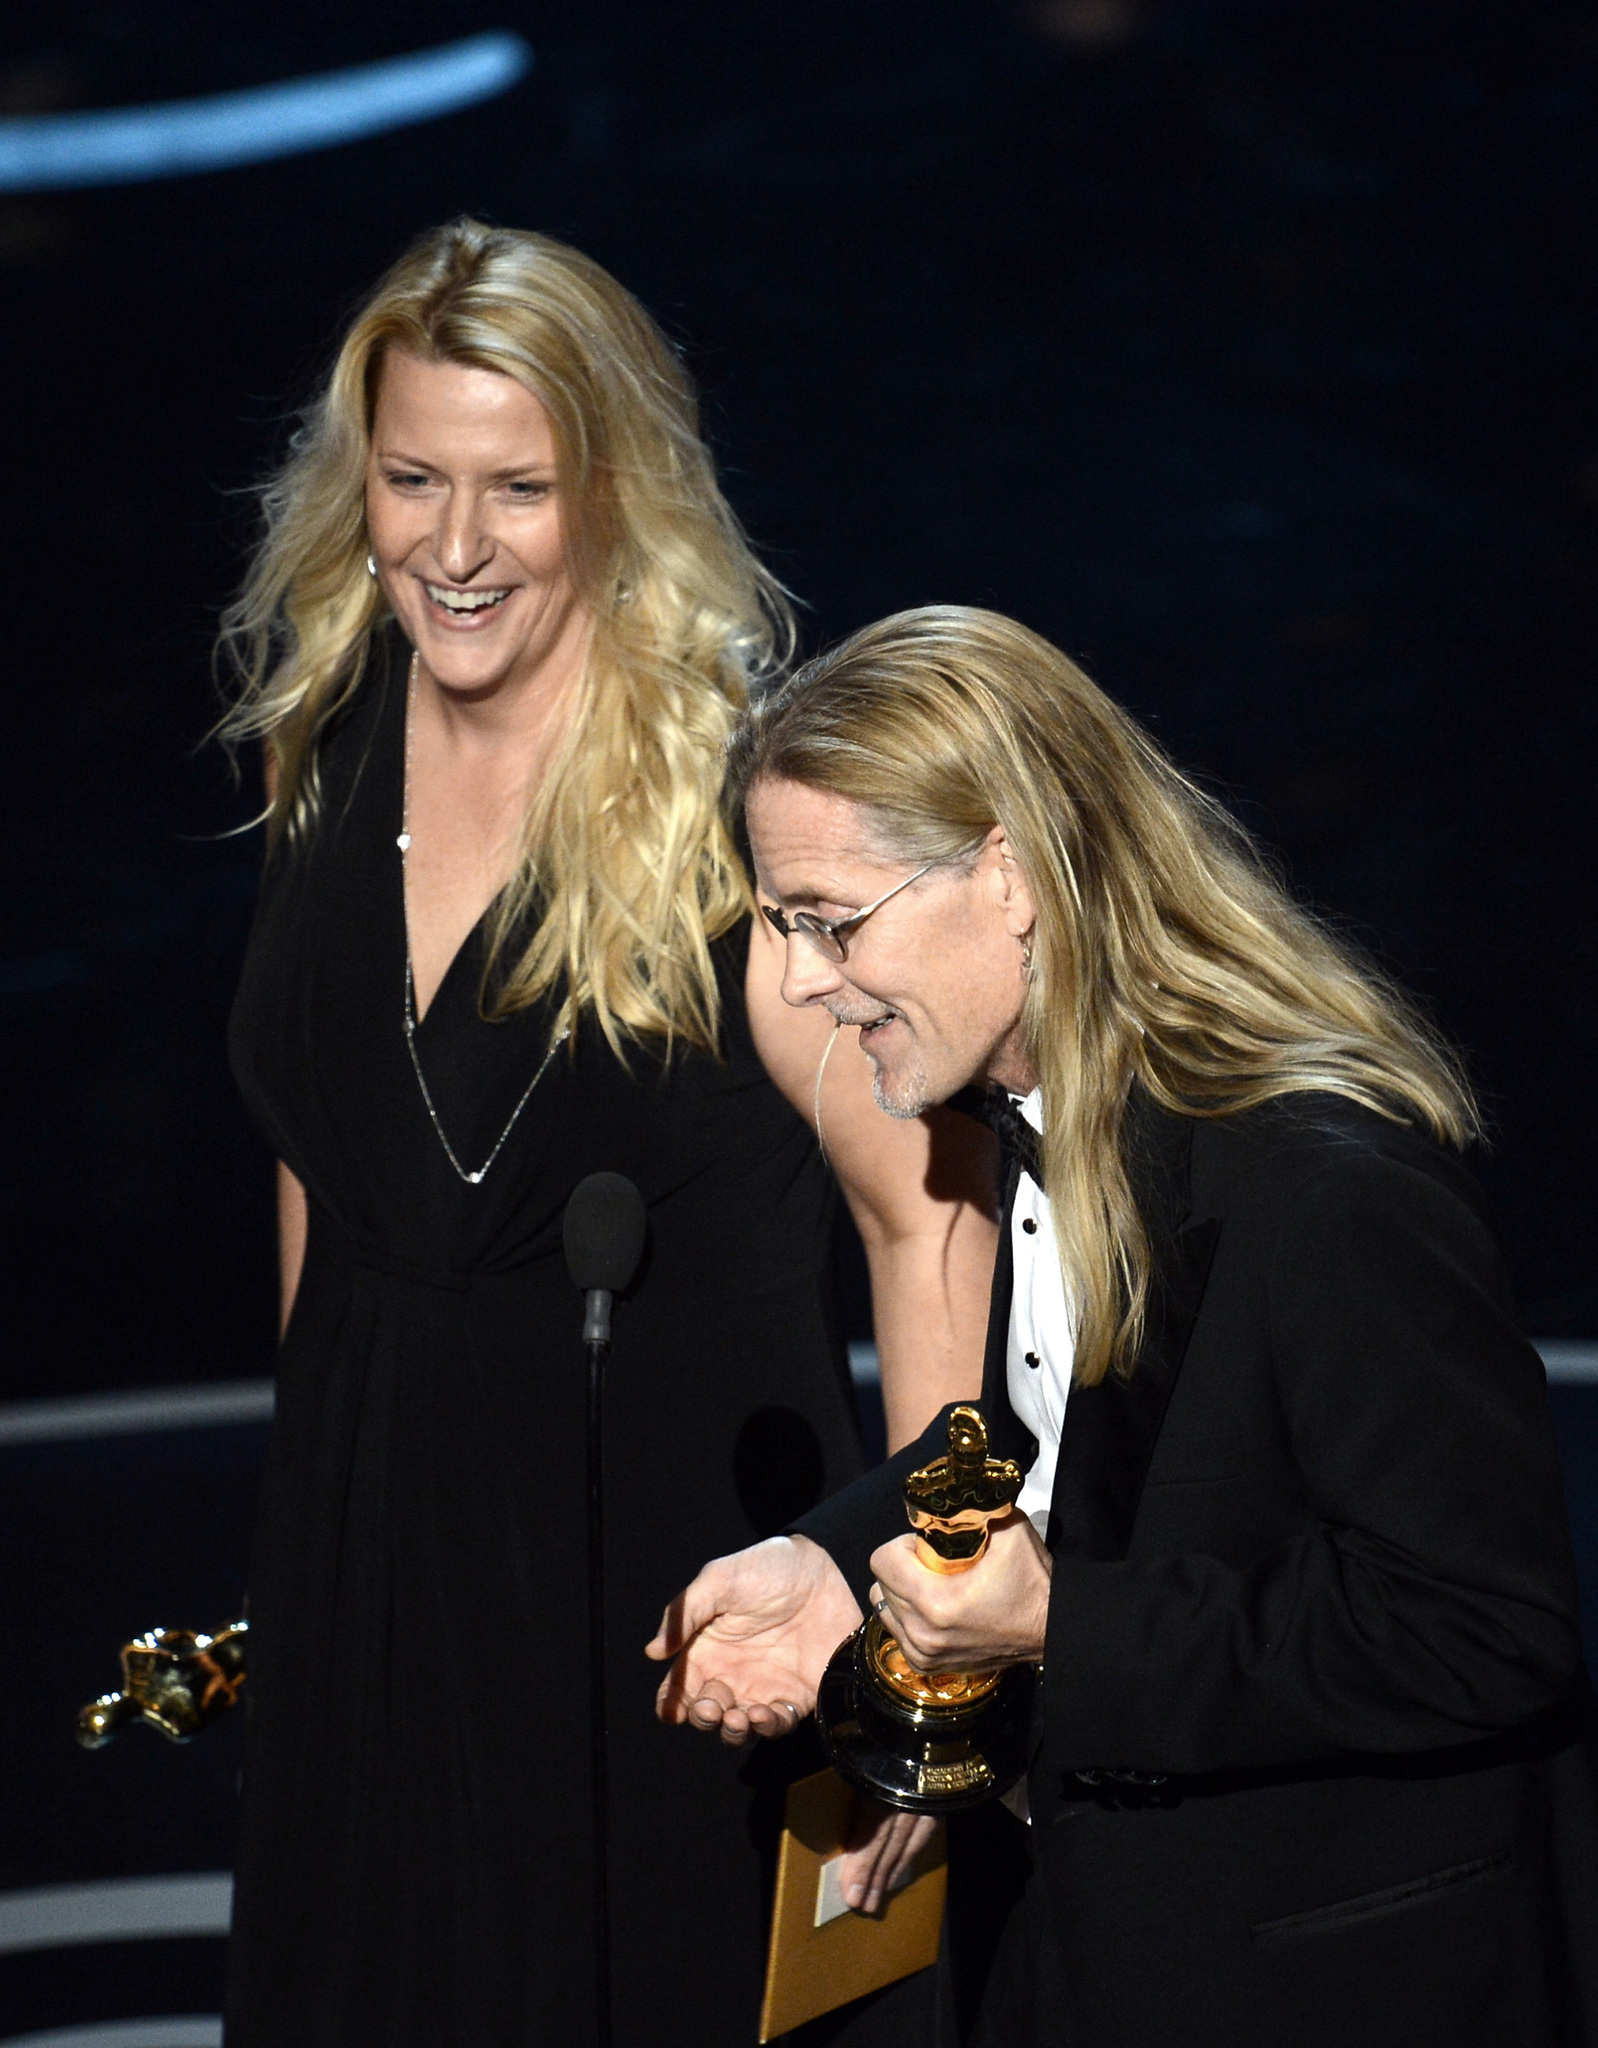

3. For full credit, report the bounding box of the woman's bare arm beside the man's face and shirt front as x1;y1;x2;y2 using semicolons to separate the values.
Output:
746;918;998;1450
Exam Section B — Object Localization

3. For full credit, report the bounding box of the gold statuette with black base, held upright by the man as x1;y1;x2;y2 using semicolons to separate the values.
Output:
815;1407;1037;1812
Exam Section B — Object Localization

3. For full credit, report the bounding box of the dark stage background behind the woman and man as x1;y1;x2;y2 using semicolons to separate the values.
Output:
0;0;1598;2048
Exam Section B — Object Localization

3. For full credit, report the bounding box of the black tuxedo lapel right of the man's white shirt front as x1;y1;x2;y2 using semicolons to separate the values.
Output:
1048;1090;1221;1563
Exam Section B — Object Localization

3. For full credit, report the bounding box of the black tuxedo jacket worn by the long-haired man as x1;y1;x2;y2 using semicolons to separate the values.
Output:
797;1096;1598;2048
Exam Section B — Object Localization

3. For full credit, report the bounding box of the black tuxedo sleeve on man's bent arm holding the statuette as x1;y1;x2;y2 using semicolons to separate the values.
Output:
1043;1151;1582;1774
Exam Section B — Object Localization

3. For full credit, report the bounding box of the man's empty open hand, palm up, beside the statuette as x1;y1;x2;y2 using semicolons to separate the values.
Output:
643;1536;860;1743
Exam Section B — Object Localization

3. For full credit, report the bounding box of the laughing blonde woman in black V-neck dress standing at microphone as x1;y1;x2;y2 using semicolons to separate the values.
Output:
227;221;994;2048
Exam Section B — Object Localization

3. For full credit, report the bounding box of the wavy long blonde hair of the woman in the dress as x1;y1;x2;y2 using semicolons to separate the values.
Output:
221;219;793;1051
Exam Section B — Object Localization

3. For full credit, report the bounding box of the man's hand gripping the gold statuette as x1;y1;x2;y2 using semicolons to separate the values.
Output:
871;1511;1053;1671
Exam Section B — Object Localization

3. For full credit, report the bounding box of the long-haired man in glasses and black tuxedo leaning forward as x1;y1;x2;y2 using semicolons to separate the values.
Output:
651;608;1598;2048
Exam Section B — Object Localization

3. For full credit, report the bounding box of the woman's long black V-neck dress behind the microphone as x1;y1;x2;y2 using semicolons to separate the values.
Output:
227;659;916;2048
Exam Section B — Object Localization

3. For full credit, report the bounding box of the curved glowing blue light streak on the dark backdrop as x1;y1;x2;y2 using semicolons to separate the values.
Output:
0;31;533;193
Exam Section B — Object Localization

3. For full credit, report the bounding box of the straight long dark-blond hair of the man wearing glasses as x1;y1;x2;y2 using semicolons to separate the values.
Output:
731;606;1477;1384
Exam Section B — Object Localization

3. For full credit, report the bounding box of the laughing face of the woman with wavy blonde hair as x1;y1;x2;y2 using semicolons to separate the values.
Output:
367;350;586;696
